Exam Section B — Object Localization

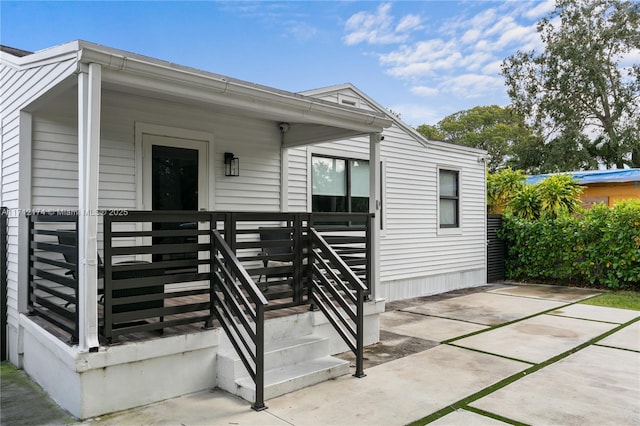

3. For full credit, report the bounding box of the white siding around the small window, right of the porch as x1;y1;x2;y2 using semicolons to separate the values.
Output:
298;86;486;301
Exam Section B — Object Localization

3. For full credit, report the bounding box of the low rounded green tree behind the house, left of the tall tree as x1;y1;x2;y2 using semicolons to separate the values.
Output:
417;105;535;172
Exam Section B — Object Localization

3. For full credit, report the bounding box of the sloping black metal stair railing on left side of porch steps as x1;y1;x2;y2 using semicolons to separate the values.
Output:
210;230;268;411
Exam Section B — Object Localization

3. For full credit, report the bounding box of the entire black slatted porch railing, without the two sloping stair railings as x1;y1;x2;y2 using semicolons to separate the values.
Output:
29;211;373;364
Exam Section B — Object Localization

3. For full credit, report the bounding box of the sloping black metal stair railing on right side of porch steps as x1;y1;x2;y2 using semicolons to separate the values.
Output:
309;228;367;377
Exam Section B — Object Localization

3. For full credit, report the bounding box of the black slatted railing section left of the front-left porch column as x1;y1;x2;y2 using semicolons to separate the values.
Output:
28;214;79;343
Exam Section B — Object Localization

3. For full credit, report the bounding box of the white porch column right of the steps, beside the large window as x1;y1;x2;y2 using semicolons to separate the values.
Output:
369;133;383;300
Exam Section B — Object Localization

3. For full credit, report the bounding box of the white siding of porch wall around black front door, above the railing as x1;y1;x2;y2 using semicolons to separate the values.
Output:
32;90;280;211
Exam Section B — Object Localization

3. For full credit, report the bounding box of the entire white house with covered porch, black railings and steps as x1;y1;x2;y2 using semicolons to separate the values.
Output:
0;41;486;418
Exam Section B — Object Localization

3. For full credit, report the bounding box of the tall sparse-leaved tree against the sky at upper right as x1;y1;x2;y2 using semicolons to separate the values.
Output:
502;0;640;170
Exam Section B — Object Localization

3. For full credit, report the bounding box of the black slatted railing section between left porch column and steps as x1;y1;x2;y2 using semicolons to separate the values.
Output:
102;211;216;341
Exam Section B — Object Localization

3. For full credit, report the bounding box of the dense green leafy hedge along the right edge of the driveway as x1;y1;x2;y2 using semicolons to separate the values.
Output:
498;200;640;290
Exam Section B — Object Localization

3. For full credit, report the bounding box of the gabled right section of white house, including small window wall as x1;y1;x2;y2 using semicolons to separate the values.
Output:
288;84;486;302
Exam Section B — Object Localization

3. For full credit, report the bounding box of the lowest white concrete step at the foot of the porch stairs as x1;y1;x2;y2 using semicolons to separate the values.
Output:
233;356;349;402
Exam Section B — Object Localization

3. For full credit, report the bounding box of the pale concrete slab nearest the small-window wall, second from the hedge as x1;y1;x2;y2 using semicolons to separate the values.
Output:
404;292;564;325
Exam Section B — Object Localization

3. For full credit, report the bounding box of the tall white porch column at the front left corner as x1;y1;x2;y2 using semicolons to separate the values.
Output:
78;64;102;352
